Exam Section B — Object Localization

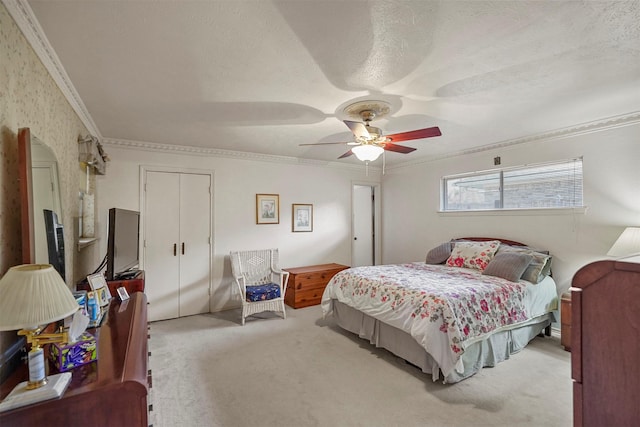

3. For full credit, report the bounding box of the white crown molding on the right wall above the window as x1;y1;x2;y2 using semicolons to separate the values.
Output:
386;111;640;170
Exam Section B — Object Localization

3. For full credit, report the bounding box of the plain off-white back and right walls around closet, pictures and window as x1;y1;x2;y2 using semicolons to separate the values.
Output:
95;124;640;311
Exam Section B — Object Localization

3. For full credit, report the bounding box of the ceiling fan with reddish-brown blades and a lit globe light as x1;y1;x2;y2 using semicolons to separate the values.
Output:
300;103;442;162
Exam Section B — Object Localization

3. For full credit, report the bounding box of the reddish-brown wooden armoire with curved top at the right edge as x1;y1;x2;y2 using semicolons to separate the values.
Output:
571;261;640;427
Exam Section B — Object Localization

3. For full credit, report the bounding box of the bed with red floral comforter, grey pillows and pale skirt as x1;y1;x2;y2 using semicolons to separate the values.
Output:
321;238;558;383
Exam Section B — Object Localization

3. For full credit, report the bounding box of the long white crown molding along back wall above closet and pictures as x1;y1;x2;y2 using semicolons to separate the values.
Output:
102;138;382;172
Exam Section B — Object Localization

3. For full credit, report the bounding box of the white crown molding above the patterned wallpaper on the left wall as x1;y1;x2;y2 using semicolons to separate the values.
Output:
2;0;102;139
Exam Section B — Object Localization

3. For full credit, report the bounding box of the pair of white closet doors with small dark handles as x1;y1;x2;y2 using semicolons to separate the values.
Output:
144;171;211;321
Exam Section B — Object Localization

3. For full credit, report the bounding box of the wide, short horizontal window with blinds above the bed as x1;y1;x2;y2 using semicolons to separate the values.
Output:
442;158;583;211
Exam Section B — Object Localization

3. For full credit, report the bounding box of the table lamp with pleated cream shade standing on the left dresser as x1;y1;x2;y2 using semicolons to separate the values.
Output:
0;264;79;411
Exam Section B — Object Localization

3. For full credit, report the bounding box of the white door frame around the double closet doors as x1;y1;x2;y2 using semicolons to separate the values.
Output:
138;165;215;311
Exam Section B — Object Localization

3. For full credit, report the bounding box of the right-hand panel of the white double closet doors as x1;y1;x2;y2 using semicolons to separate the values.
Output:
179;174;211;316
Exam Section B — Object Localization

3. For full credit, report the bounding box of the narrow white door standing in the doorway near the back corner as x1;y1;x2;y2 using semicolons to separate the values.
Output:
351;184;375;267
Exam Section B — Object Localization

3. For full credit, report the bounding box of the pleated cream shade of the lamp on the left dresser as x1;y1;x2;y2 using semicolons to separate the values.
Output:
0;264;79;331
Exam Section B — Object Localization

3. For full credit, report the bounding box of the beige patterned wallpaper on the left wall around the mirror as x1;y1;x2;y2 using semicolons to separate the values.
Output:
0;3;88;284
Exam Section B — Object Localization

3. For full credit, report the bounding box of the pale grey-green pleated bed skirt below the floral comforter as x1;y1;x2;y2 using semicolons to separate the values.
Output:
332;300;554;383
